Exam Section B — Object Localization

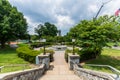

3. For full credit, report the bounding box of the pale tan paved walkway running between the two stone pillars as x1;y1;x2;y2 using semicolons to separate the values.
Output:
39;51;80;80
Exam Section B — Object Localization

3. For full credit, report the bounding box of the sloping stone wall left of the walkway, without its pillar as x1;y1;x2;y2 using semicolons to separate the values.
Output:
0;64;45;80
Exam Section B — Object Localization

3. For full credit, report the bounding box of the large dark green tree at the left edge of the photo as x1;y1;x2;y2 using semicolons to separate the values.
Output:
0;0;27;48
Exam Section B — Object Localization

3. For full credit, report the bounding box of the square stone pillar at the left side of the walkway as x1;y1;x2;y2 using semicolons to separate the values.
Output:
36;54;50;69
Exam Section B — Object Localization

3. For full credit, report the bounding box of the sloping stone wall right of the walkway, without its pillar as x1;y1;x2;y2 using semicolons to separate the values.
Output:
74;65;115;80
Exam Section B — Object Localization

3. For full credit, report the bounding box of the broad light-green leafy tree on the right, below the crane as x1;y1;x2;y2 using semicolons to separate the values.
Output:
68;15;120;60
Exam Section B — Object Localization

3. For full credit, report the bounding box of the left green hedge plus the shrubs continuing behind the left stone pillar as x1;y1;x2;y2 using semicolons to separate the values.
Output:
16;46;55;63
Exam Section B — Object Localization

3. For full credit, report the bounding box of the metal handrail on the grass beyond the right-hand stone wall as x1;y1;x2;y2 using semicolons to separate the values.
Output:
85;64;120;80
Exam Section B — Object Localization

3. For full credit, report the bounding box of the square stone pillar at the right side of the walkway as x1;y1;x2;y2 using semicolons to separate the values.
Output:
68;54;80;70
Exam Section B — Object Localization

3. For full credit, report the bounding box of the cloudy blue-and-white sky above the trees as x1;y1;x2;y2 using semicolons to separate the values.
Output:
9;0;120;35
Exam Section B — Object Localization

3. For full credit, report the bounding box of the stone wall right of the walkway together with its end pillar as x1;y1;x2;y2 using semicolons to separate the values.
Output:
68;55;117;80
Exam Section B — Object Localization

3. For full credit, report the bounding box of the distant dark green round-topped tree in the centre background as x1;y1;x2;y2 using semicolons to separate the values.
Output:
35;22;58;38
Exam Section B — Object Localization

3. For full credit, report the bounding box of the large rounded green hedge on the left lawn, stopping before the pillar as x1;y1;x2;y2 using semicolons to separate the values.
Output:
16;46;40;63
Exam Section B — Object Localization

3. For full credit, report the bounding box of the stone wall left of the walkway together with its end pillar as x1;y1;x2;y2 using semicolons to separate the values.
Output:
0;54;50;80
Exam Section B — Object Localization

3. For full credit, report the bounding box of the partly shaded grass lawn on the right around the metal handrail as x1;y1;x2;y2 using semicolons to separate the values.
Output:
84;48;120;72
